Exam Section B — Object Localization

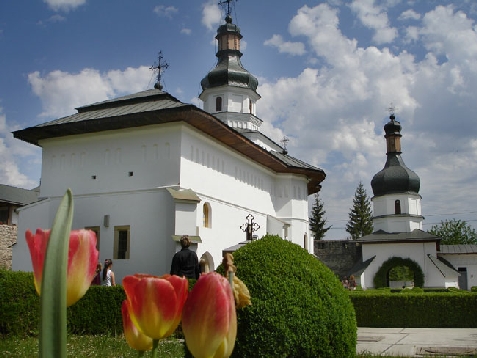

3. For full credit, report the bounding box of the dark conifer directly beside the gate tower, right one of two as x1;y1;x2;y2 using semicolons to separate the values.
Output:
346;182;373;240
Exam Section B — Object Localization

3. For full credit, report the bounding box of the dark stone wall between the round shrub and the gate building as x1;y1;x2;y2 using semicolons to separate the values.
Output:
314;240;362;279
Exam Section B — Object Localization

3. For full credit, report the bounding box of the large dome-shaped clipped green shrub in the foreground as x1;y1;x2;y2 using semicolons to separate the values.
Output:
225;235;357;358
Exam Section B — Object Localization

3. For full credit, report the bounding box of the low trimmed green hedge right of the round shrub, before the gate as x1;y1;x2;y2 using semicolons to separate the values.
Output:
350;290;477;328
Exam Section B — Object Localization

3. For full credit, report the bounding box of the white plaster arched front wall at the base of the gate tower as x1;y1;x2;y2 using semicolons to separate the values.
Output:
362;242;445;288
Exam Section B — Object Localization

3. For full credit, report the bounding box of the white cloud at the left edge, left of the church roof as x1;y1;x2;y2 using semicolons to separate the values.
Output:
0;107;40;189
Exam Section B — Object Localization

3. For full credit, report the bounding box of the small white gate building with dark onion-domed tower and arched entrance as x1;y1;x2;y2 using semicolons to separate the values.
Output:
349;114;477;289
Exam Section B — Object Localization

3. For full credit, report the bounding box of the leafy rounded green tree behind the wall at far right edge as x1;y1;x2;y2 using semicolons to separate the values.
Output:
429;219;477;245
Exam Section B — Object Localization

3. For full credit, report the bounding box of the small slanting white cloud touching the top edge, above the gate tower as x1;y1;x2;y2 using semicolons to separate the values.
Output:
350;0;397;45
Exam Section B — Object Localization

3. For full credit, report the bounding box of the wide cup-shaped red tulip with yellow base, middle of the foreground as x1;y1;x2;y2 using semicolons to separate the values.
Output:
123;274;189;340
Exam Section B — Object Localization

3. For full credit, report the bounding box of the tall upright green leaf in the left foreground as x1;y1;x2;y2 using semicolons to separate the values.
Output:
40;189;73;358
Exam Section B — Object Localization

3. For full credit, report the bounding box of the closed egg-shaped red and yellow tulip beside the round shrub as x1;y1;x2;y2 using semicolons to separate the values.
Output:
182;272;237;358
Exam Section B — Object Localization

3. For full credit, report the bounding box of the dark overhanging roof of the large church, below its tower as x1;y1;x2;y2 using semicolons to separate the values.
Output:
13;89;326;195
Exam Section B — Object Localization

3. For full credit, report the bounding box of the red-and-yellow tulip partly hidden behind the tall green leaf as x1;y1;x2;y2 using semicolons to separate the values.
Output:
25;229;99;306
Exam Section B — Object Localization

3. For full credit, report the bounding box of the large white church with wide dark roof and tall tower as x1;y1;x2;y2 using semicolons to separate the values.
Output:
12;16;325;283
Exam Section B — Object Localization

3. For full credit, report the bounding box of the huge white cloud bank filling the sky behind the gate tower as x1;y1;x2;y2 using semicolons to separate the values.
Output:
257;1;477;238
